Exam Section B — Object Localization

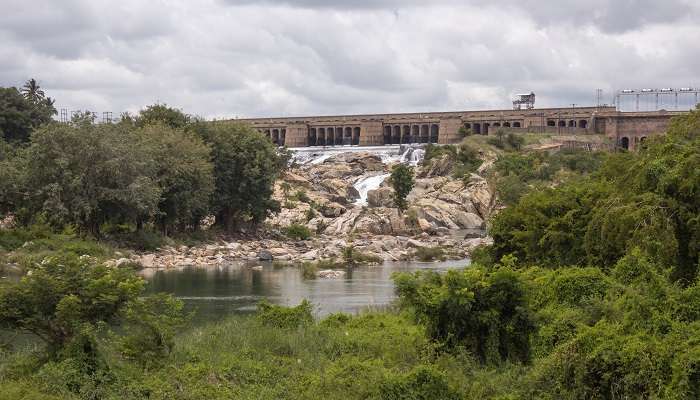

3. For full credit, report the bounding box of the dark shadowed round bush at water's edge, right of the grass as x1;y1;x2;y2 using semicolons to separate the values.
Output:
395;267;534;364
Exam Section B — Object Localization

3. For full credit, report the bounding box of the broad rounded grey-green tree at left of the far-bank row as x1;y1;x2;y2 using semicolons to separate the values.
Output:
16;123;161;236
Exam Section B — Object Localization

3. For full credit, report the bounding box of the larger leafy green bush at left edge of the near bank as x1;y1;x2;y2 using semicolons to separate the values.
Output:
0;257;143;355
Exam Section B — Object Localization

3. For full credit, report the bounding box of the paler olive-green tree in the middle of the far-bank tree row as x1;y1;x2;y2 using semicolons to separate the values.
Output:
136;123;214;234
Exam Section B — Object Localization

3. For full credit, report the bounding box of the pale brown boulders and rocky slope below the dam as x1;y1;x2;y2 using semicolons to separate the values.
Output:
126;147;496;268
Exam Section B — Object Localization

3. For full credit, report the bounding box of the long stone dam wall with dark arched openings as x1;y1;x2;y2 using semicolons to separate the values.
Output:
239;106;683;150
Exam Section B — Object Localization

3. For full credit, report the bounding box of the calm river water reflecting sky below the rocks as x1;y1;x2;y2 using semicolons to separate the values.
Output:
143;260;469;322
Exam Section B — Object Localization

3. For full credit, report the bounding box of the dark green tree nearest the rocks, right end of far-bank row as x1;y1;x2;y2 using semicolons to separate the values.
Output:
197;122;287;232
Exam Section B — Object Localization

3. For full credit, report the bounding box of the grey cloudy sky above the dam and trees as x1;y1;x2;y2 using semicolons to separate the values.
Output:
0;0;700;118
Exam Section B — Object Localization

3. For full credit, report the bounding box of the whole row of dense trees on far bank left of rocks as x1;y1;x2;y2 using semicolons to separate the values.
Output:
0;105;287;242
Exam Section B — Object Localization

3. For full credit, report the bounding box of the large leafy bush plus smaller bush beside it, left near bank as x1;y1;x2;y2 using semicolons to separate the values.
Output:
0;255;184;368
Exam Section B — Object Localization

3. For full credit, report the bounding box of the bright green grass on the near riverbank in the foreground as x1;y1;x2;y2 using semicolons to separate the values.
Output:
0;305;519;400
